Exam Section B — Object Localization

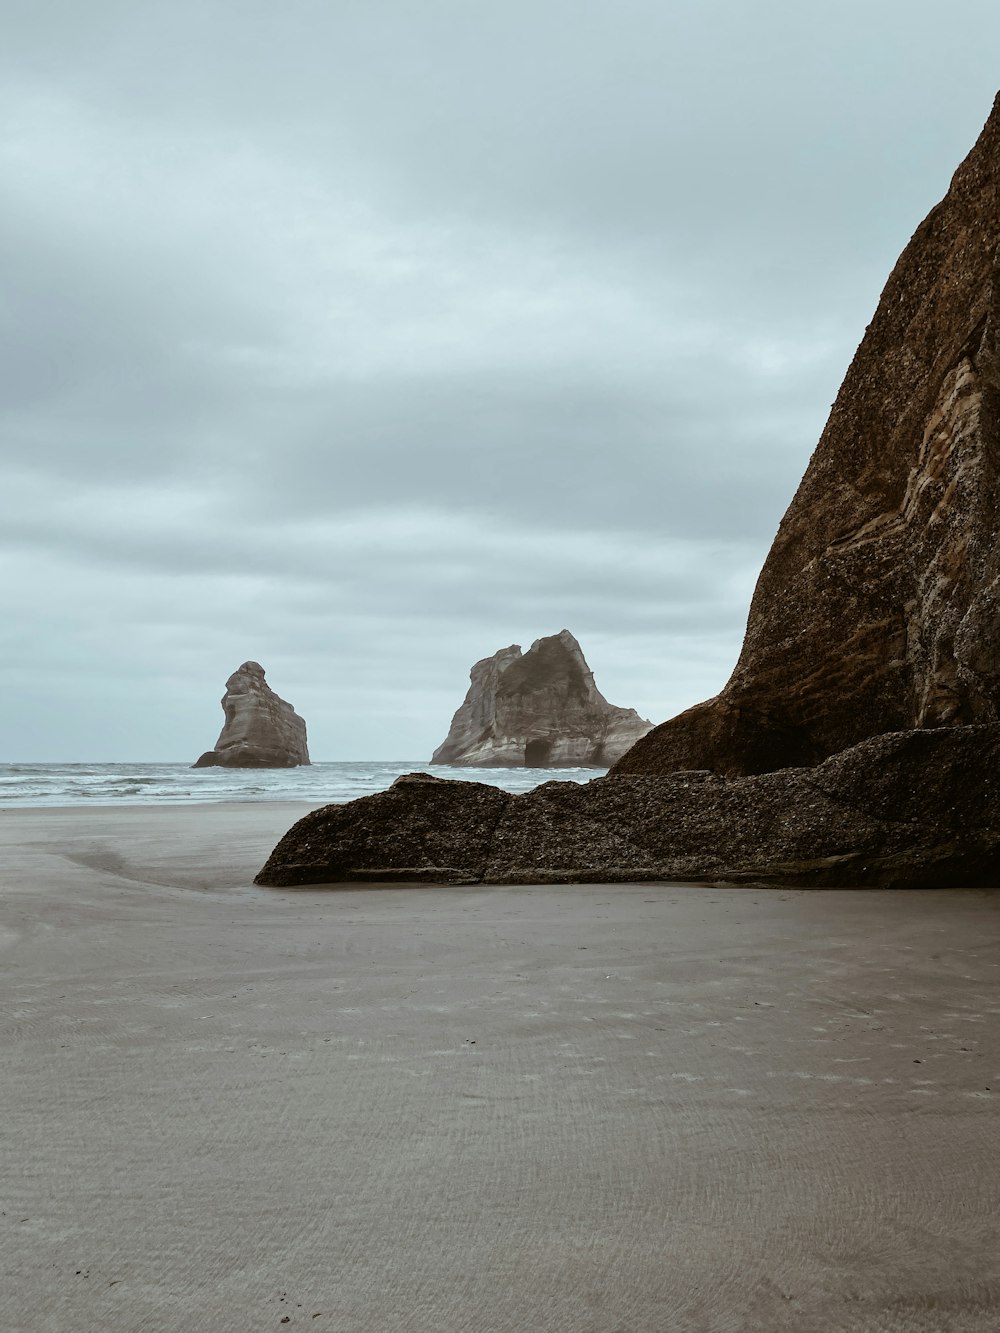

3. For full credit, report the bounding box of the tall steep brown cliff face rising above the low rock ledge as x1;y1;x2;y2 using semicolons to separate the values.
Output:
615;97;1000;774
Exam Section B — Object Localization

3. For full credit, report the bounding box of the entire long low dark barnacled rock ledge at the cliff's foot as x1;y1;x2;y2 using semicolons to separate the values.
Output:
256;725;1000;888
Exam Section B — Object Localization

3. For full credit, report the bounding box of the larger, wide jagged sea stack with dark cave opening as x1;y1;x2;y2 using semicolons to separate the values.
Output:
431;629;652;768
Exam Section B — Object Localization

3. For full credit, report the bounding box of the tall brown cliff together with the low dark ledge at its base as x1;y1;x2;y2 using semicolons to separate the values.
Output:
259;96;1000;886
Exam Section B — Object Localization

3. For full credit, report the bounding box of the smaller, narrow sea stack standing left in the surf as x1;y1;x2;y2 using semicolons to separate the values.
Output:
192;663;309;768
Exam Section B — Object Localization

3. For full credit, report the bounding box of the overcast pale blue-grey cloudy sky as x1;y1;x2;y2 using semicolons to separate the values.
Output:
0;0;1000;762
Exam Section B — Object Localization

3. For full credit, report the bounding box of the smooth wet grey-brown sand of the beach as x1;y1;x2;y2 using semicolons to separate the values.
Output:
0;805;1000;1333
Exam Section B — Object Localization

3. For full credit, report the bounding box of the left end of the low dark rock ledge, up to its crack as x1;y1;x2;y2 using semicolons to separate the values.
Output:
255;773;515;886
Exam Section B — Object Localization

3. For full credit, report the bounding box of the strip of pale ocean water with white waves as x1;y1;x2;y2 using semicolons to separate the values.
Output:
0;760;605;808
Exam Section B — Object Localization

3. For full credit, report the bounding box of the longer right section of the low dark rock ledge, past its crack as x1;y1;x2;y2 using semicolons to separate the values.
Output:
487;726;1000;888
